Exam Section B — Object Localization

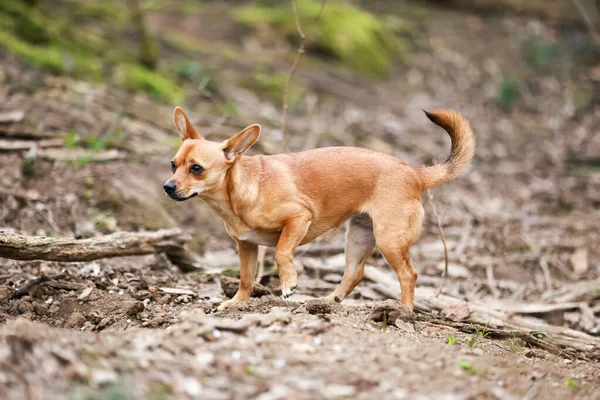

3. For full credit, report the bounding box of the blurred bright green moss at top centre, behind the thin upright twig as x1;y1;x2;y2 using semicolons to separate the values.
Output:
235;0;406;76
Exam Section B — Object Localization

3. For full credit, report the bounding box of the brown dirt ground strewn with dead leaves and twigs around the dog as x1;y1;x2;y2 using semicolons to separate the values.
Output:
0;3;600;400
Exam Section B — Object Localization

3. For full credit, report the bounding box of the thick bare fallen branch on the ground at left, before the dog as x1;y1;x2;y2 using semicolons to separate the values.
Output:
0;229;199;271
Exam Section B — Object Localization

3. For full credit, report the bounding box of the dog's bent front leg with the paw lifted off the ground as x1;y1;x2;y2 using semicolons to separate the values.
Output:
275;217;310;298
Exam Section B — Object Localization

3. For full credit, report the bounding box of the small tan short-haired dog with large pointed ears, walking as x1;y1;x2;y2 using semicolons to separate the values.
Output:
164;107;475;309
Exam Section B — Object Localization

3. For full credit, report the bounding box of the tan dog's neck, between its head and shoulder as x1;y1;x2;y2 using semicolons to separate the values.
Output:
202;156;262;227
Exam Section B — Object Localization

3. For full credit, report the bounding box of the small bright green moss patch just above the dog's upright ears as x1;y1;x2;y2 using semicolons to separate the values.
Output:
114;64;184;104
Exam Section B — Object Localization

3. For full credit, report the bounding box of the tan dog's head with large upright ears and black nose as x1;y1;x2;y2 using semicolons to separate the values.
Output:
163;107;260;201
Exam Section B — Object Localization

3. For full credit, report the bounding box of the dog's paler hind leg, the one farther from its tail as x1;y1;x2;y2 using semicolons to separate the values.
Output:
327;214;375;303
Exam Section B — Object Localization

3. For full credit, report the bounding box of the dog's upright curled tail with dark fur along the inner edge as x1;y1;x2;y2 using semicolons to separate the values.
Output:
417;110;475;191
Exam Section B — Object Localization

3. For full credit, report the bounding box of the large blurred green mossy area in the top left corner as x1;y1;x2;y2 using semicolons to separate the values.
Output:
0;0;184;103
